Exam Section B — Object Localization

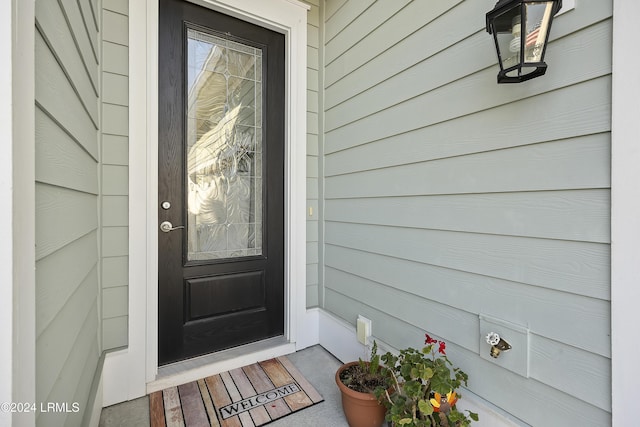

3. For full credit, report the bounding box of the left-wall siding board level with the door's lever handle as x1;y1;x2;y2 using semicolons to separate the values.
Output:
36;184;98;260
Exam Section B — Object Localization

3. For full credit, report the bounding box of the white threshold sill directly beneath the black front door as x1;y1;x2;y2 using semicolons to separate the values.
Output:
147;336;296;394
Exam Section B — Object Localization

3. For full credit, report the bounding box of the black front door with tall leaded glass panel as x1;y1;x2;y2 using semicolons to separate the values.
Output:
158;0;285;365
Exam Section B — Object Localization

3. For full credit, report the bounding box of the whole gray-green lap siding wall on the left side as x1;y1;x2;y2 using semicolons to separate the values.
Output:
34;0;101;427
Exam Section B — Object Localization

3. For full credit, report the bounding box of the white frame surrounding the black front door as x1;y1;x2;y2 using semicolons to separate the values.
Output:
103;0;310;406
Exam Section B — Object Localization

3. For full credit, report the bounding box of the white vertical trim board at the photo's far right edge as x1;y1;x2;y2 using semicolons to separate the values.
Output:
611;0;640;427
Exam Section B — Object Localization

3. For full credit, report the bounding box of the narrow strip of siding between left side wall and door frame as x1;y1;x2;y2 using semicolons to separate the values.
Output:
100;0;129;349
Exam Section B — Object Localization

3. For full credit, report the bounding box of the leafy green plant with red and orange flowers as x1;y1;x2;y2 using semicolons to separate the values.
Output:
376;334;478;427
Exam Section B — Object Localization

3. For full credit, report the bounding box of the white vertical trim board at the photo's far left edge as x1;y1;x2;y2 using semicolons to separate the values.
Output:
0;0;36;427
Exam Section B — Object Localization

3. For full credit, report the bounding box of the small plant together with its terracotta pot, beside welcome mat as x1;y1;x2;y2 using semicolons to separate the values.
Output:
335;341;389;427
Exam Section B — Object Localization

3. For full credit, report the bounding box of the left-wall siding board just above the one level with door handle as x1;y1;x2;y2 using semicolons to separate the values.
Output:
35;107;98;194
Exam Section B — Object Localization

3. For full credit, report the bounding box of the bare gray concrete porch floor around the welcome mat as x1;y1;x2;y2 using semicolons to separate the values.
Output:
100;345;348;427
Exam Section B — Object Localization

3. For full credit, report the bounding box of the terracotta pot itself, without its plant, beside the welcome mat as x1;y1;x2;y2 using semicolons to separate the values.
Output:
336;362;387;427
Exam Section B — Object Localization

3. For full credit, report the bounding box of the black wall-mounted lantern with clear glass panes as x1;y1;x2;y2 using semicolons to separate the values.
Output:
487;0;562;83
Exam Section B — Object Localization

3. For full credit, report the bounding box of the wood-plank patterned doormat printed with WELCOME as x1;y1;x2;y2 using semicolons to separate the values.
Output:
149;357;323;427
